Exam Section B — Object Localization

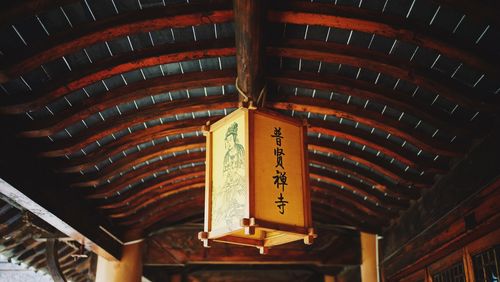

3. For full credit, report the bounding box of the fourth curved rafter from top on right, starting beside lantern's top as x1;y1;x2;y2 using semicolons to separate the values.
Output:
267;96;466;157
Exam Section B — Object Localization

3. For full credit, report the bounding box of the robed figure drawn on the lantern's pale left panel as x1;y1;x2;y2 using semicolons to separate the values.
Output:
214;122;246;230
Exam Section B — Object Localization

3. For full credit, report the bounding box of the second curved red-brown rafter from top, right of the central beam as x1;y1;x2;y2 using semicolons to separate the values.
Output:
266;39;500;112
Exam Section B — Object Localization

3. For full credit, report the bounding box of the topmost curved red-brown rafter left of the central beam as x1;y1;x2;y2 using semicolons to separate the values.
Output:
3;0;233;78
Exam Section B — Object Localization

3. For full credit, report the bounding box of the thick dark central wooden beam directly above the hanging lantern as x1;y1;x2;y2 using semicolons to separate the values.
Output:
233;0;267;102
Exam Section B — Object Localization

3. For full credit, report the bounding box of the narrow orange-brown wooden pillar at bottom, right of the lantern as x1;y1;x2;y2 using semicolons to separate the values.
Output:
361;232;379;282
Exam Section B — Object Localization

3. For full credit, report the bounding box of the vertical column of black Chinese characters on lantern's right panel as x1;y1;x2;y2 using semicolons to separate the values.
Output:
271;127;288;214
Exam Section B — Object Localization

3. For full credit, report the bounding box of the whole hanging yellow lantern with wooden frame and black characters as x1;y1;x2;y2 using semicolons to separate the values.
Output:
198;107;316;254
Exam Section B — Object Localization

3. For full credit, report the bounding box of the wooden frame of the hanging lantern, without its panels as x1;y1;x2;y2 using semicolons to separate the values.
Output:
198;107;317;254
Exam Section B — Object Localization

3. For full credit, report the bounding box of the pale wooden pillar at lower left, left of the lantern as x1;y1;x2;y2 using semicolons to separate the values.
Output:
96;241;144;282
